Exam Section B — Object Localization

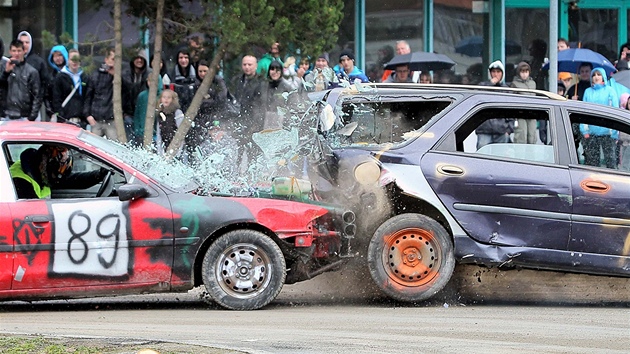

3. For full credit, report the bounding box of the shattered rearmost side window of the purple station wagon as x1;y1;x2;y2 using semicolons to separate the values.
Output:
321;96;452;148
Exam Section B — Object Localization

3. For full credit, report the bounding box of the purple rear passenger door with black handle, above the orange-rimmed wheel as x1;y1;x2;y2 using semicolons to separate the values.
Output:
421;108;571;250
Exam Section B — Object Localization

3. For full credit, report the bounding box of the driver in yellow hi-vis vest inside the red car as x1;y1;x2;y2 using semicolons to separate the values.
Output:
9;144;107;199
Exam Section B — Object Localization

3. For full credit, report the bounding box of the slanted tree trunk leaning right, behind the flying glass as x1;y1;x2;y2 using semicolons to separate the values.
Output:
165;41;227;159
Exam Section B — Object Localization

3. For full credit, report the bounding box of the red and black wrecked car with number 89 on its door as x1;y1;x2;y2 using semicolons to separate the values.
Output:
0;122;354;310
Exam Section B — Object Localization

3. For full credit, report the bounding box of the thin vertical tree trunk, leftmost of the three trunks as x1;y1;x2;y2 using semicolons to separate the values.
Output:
113;0;127;144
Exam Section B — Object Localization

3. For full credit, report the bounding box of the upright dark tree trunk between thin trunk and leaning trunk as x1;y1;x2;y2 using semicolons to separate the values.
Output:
143;0;164;149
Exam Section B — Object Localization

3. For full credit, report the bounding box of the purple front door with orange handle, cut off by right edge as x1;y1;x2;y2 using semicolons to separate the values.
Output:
569;112;630;258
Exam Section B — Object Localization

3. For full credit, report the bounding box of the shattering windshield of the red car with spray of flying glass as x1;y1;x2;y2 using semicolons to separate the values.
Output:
79;102;317;196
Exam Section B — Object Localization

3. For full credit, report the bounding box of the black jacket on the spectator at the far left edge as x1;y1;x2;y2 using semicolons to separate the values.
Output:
0;61;43;121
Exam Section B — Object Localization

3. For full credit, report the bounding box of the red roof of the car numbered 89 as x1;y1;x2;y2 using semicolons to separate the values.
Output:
0;121;83;139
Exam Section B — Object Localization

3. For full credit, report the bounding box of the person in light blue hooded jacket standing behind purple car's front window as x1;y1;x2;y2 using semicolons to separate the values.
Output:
580;68;619;169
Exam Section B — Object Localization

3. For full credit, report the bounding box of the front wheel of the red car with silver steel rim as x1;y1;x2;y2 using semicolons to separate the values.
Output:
202;230;286;310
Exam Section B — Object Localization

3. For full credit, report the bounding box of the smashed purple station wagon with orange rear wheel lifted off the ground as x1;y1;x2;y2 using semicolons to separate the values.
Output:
312;84;630;302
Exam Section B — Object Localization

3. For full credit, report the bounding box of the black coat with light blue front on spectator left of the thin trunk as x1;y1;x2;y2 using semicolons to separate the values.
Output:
51;66;88;124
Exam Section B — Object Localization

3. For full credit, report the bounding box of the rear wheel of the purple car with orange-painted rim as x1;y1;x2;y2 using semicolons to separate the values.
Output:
368;214;455;302
